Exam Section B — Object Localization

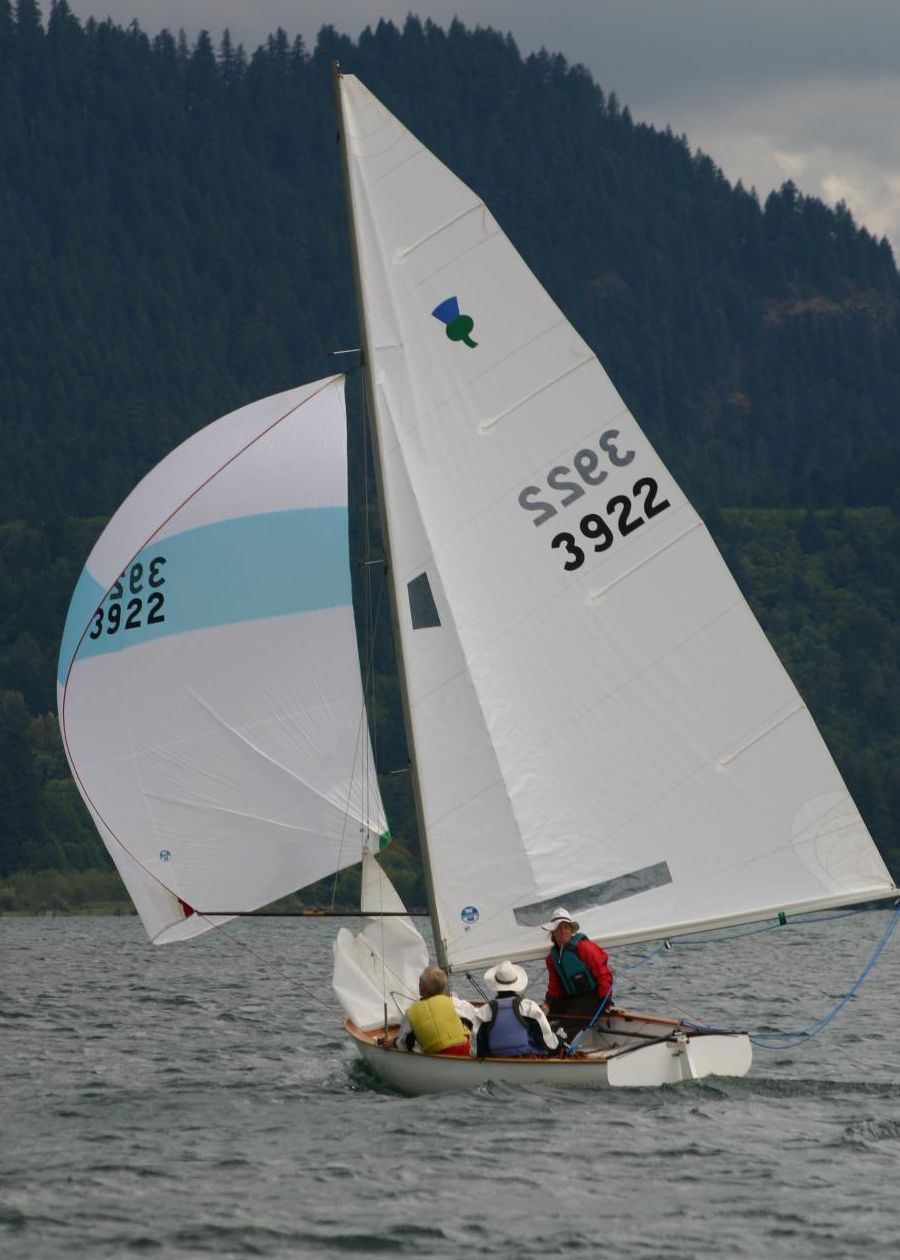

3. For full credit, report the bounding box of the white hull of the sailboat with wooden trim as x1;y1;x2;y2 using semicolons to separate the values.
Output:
344;1011;753;1094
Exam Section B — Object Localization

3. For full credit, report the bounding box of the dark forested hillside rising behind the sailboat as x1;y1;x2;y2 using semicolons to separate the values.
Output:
0;0;900;906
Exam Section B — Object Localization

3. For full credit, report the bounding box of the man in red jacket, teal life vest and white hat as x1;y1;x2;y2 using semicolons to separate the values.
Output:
541;906;613;1032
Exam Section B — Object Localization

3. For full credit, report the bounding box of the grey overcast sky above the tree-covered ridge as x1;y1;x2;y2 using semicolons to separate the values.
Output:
59;0;900;258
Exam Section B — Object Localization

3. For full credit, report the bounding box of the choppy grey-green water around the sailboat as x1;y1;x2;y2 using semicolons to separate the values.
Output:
0;914;900;1260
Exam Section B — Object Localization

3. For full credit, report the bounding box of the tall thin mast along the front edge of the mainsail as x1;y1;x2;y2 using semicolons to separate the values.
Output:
332;62;447;970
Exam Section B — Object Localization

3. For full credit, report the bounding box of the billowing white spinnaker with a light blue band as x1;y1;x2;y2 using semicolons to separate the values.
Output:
58;377;384;942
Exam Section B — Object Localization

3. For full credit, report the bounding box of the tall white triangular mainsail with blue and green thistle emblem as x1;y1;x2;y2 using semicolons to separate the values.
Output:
340;76;891;966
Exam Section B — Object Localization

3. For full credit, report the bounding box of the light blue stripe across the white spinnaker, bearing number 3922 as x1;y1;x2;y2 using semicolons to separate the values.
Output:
59;508;350;683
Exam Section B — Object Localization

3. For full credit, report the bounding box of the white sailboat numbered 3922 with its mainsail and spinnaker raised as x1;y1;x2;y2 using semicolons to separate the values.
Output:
58;71;896;1094
